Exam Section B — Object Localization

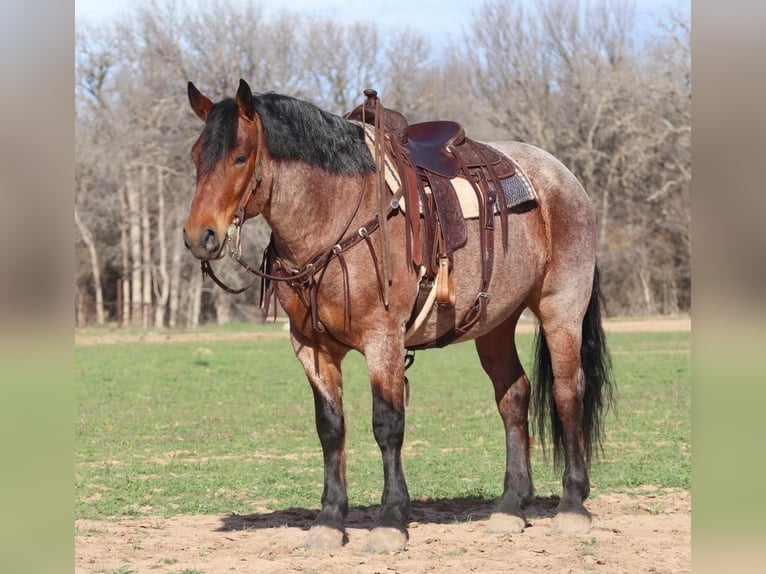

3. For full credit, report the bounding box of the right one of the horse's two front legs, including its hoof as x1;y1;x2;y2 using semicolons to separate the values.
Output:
365;344;410;552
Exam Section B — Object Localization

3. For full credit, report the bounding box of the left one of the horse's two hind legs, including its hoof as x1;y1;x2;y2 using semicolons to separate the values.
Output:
476;315;535;534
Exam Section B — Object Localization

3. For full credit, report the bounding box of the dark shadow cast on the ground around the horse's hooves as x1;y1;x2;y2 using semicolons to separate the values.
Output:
216;495;559;532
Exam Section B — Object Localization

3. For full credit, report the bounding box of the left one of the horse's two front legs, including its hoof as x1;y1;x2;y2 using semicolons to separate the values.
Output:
293;337;348;549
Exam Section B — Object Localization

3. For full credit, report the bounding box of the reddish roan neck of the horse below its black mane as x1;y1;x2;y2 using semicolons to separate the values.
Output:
263;161;373;267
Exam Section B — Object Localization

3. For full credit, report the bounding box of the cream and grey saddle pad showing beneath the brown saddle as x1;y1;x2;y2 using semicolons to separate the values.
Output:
353;121;537;219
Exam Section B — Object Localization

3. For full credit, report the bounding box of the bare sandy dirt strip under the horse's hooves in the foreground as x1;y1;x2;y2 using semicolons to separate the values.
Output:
75;490;691;574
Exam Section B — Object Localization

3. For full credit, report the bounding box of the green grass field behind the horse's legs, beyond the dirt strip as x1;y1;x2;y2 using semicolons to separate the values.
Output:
75;329;691;518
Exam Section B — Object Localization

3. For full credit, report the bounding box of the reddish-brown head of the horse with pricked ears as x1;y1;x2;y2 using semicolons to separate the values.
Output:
183;80;266;260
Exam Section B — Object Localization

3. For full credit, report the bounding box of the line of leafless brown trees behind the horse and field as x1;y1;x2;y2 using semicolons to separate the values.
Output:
75;0;691;327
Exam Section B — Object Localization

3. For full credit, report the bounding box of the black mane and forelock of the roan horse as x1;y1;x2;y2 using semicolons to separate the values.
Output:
201;92;375;175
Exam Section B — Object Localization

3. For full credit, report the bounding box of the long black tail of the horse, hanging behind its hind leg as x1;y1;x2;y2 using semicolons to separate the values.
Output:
533;267;614;467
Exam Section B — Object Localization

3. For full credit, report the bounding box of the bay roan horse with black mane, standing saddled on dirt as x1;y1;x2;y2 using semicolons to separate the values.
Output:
183;80;614;552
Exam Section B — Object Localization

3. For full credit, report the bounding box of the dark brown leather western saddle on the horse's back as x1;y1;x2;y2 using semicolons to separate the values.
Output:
346;89;515;348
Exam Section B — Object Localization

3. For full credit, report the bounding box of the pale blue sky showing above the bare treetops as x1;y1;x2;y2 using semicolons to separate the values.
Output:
75;0;691;44
